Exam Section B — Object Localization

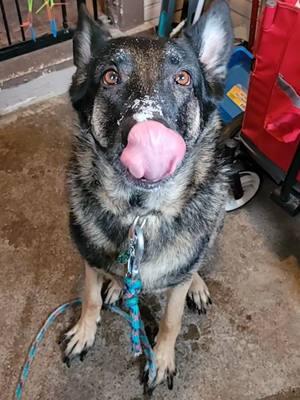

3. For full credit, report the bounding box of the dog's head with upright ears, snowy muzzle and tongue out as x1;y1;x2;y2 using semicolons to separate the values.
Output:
70;0;232;189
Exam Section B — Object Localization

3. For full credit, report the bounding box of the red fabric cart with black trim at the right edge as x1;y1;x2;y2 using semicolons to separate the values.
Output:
241;0;300;213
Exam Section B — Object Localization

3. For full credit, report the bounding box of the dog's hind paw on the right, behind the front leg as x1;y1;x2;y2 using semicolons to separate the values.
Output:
186;272;212;314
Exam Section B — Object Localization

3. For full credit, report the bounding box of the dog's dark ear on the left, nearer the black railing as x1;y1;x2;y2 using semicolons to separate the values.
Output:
73;3;110;68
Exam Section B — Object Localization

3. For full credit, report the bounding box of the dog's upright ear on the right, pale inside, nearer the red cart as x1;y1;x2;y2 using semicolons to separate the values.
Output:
184;0;233;96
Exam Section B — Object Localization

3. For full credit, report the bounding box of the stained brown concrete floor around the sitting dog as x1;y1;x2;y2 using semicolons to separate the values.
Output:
0;98;300;400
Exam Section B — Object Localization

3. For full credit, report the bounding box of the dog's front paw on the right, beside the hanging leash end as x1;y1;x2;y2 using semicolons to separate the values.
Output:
143;342;177;395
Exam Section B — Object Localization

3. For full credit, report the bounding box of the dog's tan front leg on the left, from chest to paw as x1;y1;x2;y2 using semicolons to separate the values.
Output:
64;262;103;365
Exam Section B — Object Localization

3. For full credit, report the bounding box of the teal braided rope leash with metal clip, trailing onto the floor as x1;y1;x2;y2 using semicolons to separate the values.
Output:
15;217;157;400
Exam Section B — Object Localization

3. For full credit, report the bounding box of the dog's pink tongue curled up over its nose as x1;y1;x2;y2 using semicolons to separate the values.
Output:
121;120;186;182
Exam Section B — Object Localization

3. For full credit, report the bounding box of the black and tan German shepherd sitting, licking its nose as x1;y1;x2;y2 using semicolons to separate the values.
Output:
65;0;233;390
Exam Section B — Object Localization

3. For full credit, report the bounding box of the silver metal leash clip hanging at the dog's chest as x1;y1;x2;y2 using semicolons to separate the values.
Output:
127;217;146;279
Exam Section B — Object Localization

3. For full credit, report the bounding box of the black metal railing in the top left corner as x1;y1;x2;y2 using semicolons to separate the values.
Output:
0;0;101;61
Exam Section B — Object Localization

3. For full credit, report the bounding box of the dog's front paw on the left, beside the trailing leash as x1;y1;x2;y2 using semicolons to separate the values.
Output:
63;319;97;367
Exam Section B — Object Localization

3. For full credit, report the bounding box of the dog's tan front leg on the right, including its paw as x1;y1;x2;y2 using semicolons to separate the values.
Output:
148;280;191;391
